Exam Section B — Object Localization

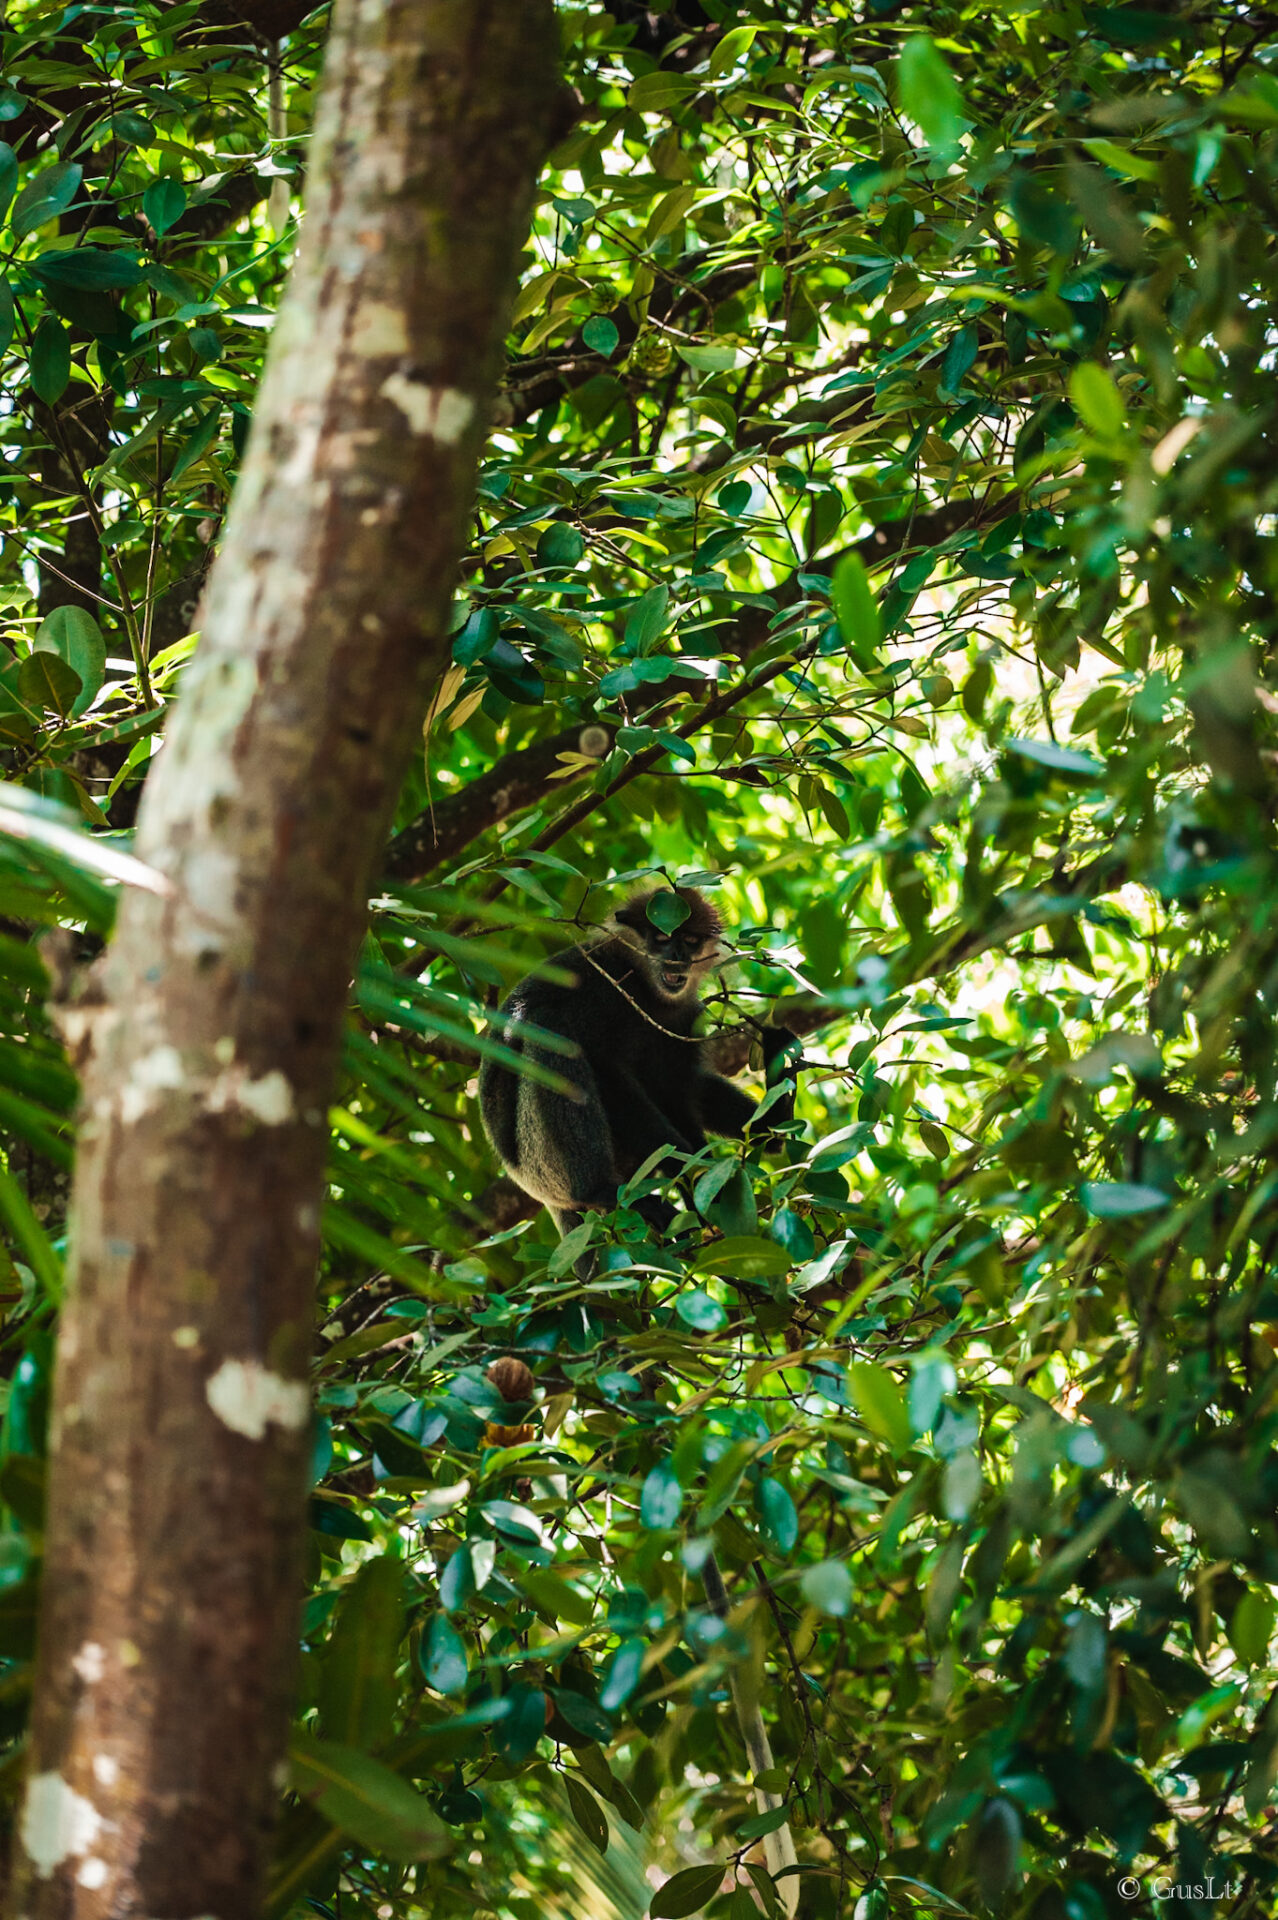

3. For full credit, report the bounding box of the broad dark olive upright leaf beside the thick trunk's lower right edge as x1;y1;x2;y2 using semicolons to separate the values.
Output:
319;1553;405;1747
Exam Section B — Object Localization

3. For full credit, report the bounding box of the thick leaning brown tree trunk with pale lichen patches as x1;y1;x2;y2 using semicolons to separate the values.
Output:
13;0;562;1920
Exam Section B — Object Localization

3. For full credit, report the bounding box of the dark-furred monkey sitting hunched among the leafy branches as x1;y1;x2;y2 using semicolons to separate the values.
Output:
480;887;791;1233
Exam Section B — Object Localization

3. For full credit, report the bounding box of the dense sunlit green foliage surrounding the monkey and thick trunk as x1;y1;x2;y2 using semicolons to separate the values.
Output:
0;0;1278;1920
